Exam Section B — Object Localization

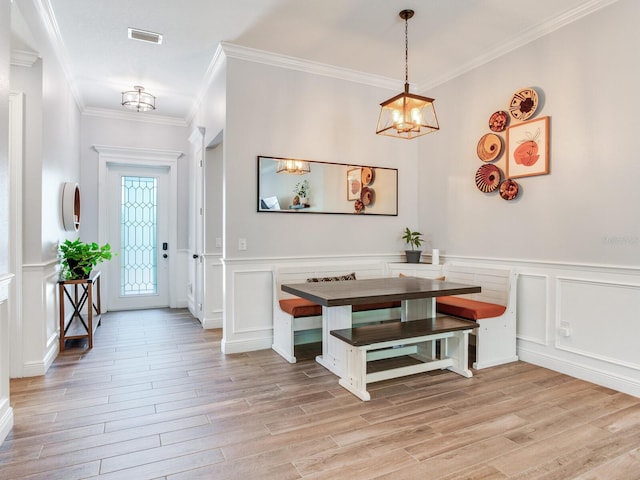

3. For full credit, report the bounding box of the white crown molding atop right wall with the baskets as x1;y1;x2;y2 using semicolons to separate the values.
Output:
416;0;618;94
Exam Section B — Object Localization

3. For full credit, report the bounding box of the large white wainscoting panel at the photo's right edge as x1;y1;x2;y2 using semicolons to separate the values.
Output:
556;277;640;370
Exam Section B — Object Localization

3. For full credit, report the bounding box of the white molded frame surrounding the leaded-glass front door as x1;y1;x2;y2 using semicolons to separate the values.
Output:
93;145;183;312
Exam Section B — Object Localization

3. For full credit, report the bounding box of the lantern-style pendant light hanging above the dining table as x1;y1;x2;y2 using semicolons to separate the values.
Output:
376;10;440;139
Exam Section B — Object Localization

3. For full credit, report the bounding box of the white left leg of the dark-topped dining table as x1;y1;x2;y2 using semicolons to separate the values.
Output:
316;305;351;377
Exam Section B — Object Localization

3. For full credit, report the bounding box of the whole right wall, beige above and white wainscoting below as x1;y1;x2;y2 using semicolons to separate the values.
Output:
418;0;640;395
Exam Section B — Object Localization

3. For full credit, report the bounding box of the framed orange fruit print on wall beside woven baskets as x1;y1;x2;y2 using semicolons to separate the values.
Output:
505;117;549;178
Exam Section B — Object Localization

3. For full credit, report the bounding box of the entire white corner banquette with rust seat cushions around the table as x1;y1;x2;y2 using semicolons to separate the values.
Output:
272;262;518;369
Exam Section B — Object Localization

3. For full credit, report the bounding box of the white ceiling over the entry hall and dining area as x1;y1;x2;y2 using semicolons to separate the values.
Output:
12;0;615;121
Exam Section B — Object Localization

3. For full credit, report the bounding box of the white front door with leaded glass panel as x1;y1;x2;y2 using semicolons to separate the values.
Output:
106;164;175;310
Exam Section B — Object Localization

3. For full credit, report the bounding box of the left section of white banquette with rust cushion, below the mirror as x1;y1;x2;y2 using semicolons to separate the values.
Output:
271;262;401;363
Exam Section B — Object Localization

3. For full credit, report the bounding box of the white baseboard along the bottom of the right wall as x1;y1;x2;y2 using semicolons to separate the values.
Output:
518;347;640;397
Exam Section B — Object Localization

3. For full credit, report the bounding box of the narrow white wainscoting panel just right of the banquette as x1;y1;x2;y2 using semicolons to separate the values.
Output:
517;273;549;345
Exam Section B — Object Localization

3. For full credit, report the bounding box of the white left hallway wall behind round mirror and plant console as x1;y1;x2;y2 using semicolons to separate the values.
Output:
10;1;80;376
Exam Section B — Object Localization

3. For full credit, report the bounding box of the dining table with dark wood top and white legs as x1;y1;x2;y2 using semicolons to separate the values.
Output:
281;277;481;376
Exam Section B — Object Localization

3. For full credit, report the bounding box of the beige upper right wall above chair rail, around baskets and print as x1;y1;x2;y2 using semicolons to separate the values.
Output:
418;0;640;267
